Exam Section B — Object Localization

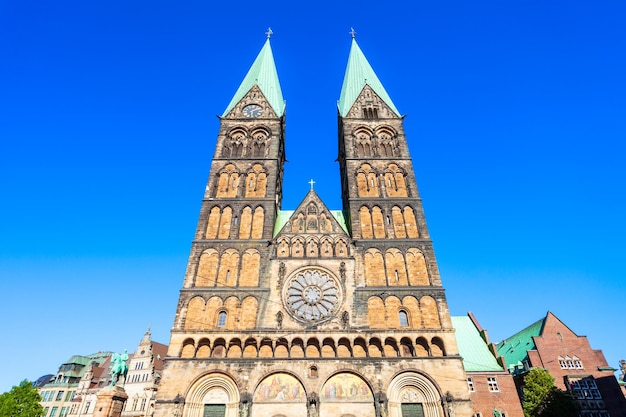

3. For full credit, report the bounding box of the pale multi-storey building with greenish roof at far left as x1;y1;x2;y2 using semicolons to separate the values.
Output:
39;352;112;417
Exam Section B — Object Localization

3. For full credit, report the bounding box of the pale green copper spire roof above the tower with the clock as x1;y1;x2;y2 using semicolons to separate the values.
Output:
222;37;285;117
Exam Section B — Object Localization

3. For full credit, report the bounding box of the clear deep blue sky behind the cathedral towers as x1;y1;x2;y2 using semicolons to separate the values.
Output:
0;0;626;392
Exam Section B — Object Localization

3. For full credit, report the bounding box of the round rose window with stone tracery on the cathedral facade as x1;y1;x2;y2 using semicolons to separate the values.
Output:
284;269;341;323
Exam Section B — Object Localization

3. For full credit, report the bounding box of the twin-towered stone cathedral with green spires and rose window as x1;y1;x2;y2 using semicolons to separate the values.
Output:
154;36;473;417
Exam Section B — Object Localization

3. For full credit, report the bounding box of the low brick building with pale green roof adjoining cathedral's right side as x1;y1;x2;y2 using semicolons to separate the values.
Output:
452;313;524;417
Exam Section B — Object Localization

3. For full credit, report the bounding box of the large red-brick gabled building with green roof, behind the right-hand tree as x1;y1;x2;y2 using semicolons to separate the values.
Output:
497;312;626;417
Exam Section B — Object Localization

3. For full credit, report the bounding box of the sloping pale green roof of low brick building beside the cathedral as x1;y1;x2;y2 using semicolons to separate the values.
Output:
451;316;503;372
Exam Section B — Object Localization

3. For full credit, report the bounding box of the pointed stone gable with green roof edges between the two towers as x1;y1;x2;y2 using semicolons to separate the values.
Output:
274;190;348;237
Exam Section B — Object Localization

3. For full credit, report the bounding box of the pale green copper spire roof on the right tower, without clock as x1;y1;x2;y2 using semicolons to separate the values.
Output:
337;38;400;117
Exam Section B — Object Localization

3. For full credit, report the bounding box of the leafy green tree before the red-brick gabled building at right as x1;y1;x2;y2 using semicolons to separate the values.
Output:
522;368;578;417
